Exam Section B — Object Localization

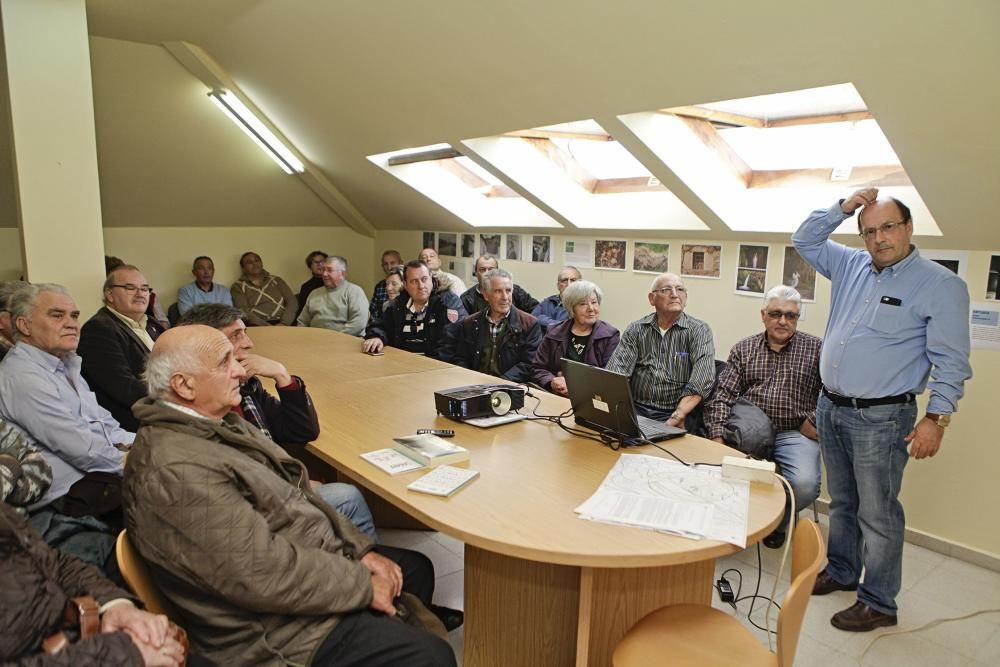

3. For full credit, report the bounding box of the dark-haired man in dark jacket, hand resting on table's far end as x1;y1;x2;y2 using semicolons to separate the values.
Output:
362;260;466;361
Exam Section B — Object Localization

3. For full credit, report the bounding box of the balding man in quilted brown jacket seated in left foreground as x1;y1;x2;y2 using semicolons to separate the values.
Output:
124;325;455;667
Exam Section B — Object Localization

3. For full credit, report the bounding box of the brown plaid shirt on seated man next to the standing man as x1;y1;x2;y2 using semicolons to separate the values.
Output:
705;331;823;438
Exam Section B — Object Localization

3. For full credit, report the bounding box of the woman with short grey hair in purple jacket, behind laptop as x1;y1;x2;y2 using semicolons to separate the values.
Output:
532;280;618;396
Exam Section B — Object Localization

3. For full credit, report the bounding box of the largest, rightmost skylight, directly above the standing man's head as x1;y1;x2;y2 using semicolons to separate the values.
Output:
619;84;941;236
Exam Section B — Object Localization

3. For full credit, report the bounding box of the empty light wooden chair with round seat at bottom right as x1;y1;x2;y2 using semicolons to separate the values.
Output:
612;519;826;667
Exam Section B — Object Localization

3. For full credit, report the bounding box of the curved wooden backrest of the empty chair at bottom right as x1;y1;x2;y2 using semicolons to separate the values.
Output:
778;519;826;667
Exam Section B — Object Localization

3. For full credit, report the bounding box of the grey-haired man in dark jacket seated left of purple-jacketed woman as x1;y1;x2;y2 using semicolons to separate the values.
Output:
443;269;542;382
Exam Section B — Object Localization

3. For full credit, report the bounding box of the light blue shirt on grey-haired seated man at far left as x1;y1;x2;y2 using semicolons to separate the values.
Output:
0;343;135;509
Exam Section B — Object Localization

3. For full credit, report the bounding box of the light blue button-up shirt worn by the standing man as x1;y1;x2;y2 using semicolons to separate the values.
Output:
792;203;972;414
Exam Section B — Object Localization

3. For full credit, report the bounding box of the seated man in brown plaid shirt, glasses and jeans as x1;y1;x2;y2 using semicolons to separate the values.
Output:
705;285;822;549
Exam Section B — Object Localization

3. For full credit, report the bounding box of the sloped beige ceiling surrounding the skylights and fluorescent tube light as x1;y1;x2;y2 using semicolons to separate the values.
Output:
3;0;1000;248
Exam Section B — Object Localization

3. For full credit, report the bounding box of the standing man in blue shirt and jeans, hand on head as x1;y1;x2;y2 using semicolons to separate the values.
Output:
792;188;972;632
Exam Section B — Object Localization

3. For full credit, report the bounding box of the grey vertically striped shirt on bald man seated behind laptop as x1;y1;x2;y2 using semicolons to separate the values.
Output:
607;313;715;411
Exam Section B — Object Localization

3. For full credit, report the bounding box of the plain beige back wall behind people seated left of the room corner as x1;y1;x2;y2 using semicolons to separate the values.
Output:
102;227;374;316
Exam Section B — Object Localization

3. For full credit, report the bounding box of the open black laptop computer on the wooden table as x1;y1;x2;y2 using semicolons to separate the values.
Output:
561;359;687;444
